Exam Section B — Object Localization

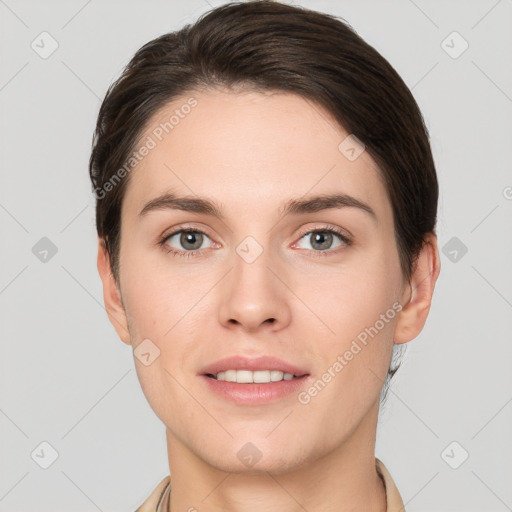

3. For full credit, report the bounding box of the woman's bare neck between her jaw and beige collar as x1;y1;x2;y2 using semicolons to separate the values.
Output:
163;407;387;512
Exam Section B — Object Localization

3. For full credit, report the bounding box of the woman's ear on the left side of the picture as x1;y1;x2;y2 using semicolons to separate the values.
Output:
98;238;131;345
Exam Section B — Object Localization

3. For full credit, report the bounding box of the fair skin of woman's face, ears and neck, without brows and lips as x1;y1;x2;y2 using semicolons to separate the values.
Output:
98;90;440;512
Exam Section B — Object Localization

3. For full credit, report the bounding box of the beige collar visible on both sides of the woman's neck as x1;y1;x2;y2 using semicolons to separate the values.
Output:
135;457;405;512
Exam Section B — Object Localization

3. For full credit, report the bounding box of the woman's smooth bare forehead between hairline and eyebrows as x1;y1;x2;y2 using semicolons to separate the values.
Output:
123;90;389;221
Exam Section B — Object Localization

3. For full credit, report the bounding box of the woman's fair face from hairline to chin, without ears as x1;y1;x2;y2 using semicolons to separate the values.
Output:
111;90;409;471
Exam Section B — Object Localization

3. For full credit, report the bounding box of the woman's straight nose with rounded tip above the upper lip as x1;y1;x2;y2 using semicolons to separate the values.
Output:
219;243;292;332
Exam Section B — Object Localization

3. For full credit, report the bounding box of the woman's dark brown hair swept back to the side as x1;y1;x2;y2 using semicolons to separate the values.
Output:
89;0;438;402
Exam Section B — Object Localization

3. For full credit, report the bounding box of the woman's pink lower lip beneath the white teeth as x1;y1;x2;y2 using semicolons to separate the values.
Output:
200;375;310;405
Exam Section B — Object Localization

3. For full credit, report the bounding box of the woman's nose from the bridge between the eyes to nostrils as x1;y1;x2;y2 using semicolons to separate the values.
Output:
219;235;289;330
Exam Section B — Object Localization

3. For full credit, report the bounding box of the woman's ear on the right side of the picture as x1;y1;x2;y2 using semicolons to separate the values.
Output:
394;233;441;343
